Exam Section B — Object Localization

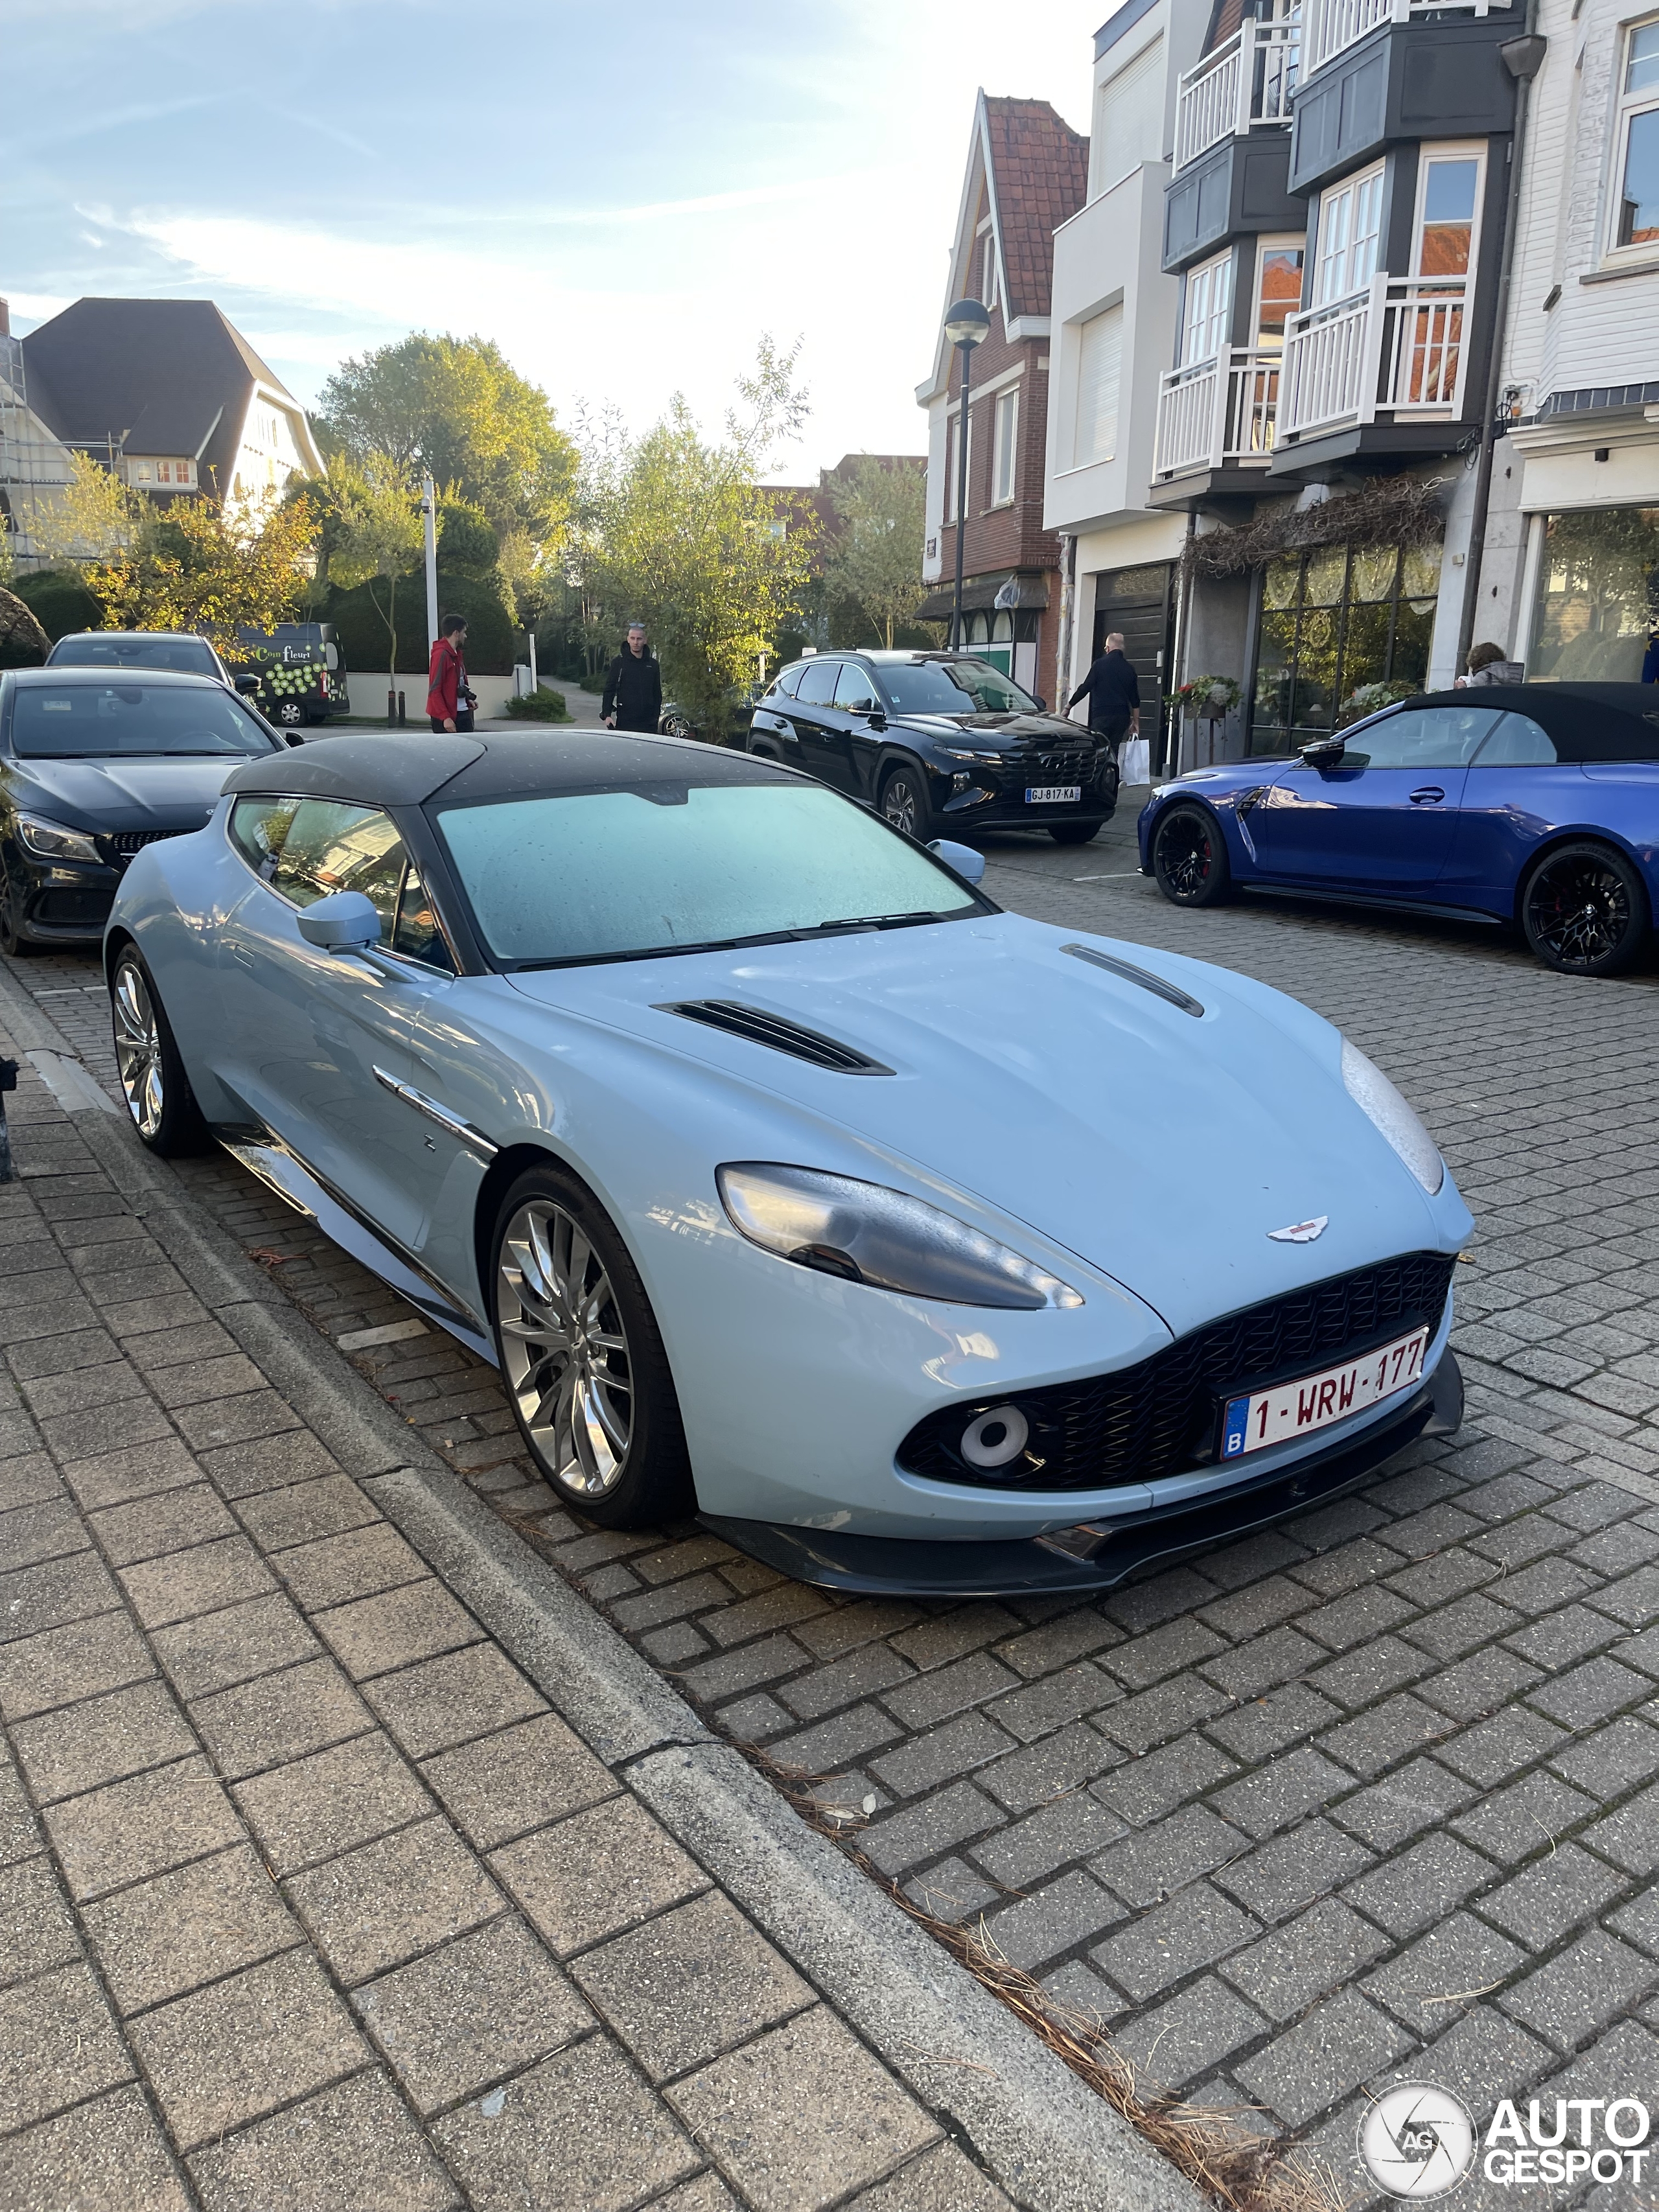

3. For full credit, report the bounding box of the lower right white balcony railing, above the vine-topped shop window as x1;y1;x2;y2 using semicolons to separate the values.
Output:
1279;277;1468;440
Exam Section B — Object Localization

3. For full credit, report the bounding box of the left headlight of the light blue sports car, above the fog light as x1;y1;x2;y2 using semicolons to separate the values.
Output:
715;1159;1084;1309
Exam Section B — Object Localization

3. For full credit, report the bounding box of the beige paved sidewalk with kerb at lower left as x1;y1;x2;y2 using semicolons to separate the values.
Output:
0;1008;1197;2212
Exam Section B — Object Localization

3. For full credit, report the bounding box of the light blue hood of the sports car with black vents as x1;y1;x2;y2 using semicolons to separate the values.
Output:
511;914;1468;1336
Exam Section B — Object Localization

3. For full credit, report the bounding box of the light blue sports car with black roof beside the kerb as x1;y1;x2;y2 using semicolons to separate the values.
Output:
104;732;1471;1595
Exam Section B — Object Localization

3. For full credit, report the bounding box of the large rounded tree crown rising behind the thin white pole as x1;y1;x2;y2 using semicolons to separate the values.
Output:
319;332;577;540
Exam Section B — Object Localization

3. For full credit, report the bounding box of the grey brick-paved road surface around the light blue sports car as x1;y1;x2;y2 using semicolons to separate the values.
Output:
16;800;1659;2203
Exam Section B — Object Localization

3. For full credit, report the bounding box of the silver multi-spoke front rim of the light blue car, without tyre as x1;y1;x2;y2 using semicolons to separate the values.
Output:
496;1199;635;1498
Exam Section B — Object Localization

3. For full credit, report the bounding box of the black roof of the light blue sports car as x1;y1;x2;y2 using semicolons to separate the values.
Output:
224;730;796;808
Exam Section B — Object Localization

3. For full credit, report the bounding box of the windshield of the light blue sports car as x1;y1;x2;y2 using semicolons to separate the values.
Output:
438;783;982;966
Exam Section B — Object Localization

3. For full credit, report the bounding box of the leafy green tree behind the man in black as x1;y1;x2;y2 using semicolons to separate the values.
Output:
577;341;814;732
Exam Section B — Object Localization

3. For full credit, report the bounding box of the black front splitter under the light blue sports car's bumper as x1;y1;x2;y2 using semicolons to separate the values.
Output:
699;1351;1462;1597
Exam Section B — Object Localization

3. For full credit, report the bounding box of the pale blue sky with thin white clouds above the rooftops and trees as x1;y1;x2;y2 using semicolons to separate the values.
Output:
0;0;1110;478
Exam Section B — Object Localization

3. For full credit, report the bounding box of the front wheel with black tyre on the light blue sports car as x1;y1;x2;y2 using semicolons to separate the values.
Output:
491;1163;695;1528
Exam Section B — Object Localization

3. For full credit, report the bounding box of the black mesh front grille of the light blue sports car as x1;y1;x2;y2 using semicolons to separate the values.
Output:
898;1252;1456;1491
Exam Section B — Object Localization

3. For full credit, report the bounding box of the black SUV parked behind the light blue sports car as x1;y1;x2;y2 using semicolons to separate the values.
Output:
748;653;1117;845
